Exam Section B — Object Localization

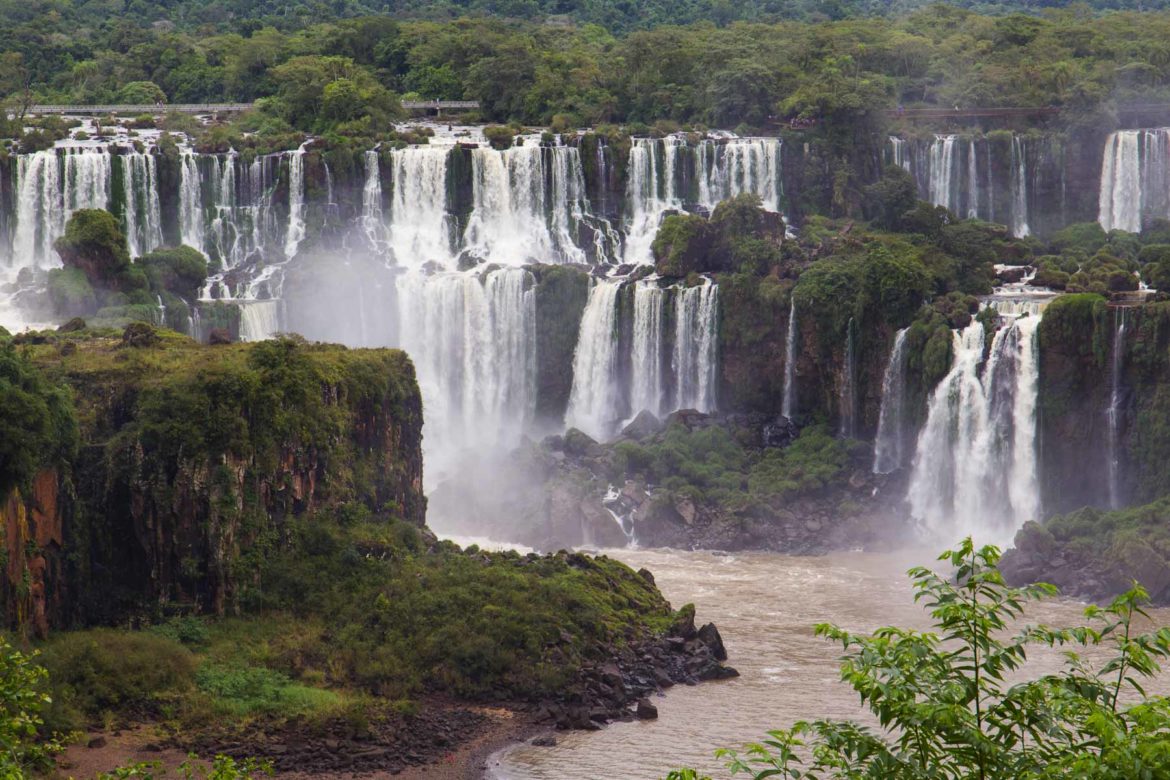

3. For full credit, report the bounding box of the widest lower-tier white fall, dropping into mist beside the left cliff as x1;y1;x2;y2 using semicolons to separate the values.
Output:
397;268;536;478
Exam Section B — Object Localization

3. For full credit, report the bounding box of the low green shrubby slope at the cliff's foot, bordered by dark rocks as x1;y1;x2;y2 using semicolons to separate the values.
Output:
34;512;674;734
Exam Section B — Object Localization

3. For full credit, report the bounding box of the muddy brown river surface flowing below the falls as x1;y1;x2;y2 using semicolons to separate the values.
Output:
477;542;1170;780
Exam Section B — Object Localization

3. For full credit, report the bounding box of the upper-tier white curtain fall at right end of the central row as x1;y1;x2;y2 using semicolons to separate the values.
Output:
695;138;783;212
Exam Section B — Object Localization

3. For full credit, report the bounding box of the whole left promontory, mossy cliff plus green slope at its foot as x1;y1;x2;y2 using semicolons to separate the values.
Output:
0;322;714;768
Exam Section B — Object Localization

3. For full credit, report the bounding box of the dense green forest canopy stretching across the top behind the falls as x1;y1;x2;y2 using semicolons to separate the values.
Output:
0;0;1170;133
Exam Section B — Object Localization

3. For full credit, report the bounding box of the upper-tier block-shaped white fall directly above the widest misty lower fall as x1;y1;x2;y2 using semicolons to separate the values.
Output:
388;146;454;268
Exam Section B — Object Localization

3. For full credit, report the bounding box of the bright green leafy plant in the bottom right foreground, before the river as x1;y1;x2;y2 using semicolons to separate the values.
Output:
668;539;1170;780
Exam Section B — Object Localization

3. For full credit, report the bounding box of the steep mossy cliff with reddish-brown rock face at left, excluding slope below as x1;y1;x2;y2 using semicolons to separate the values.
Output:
0;329;426;633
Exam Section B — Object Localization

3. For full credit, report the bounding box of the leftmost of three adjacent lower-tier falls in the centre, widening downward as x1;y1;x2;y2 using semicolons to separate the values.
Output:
565;279;622;440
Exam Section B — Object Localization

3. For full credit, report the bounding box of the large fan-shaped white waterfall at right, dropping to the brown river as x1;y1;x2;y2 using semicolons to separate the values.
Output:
908;308;1040;543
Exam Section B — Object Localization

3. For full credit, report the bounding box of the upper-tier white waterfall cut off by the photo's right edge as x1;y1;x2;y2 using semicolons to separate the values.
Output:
1097;127;1170;233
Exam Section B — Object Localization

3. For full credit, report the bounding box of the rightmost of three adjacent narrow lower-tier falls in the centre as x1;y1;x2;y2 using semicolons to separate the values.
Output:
673;279;720;412
